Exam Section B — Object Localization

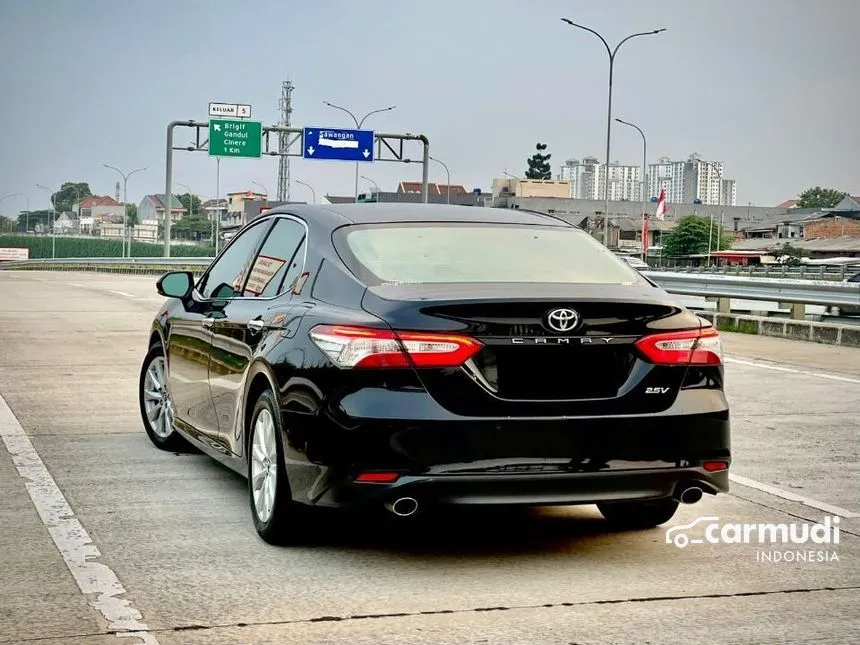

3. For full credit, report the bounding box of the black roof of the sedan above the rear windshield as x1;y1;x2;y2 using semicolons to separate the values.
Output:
266;202;573;228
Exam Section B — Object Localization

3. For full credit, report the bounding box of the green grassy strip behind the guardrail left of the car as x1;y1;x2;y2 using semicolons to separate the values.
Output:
0;235;215;259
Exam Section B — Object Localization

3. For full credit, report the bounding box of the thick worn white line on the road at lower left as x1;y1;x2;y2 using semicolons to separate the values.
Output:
0;396;159;645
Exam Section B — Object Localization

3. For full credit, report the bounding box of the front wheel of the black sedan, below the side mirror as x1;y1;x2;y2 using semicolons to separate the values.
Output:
137;342;190;452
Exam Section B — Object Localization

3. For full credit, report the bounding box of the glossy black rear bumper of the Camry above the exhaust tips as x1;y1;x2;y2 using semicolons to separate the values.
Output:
284;390;731;507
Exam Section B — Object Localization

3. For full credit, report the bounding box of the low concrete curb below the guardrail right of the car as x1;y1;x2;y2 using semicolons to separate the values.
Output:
697;311;860;347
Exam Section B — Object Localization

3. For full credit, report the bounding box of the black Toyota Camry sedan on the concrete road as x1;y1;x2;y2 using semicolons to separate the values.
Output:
140;204;731;544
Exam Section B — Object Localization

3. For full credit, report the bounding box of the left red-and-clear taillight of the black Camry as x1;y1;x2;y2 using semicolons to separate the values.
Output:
310;325;483;369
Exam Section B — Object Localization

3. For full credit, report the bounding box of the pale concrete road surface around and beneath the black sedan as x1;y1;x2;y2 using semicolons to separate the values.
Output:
0;272;860;645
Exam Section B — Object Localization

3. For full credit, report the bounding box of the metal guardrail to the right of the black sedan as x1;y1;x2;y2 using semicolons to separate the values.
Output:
642;271;860;307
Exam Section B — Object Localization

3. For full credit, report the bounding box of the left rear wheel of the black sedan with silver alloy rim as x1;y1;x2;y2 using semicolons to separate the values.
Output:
247;390;311;546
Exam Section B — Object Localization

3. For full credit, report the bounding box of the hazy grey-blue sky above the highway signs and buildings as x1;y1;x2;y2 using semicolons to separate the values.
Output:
0;0;860;215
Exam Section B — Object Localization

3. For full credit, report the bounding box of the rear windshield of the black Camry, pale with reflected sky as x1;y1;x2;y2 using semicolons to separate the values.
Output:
335;223;645;285
